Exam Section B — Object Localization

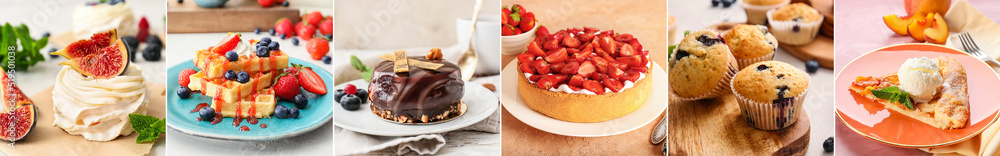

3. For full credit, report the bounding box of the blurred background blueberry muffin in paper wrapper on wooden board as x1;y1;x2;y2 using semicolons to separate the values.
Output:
767;3;823;45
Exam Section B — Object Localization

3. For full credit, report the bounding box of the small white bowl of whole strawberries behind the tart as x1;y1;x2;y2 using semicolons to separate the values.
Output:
500;4;548;55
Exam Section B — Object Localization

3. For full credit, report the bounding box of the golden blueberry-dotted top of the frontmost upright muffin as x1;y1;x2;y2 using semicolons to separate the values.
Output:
732;61;809;103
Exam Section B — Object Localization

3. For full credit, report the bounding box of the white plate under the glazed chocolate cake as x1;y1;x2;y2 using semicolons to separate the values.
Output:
333;79;500;136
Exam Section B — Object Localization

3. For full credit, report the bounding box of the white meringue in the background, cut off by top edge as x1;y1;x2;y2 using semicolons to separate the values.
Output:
73;3;139;39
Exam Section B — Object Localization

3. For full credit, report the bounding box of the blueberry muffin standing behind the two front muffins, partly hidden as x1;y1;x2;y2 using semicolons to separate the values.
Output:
722;24;778;69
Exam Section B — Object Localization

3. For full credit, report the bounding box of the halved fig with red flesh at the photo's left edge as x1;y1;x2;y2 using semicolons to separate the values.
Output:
0;70;38;141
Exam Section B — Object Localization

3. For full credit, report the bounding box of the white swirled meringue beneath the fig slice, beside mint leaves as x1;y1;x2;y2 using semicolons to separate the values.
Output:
52;64;149;141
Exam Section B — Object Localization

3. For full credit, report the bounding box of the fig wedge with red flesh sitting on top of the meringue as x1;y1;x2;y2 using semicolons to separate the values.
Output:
52;29;129;79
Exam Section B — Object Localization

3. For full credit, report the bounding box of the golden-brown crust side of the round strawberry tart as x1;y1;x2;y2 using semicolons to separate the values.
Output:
517;68;651;123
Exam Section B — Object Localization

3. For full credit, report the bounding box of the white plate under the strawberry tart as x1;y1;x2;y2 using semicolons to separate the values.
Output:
500;60;668;137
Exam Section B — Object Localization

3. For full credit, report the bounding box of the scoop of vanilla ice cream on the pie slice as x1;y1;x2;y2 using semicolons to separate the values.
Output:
897;57;944;103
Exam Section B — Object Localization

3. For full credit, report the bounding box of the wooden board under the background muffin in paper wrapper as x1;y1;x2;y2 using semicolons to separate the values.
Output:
778;35;833;69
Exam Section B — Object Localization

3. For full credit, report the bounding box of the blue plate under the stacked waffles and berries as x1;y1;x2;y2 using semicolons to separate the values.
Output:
167;58;334;140
